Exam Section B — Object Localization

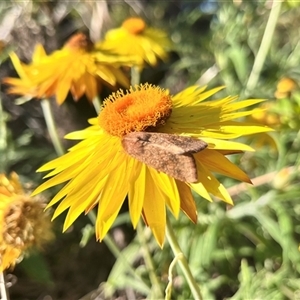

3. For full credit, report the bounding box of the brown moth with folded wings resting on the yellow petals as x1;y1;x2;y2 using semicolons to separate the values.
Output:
122;132;207;183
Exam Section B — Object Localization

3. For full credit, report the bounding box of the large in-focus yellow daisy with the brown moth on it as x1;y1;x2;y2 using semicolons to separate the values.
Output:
33;84;270;246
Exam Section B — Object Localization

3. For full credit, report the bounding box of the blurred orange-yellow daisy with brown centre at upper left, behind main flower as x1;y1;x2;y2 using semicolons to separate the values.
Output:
4;33;129;104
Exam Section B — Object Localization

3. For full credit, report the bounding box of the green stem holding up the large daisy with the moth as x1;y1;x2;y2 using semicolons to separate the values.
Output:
166;218;202;300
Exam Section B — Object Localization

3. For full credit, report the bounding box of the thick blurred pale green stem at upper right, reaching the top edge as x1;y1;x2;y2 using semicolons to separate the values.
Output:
245;0;283;96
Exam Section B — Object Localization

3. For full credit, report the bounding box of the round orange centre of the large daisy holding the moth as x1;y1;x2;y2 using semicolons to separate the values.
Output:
98;83;172;137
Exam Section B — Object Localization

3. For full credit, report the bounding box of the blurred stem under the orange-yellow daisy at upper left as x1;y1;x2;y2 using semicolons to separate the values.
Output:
41;99;65;156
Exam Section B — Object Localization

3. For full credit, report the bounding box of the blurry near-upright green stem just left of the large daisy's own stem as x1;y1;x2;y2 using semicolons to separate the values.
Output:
137;222;163;299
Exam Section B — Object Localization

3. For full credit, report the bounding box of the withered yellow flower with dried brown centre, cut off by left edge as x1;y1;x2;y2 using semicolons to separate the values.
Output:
0;173;53;272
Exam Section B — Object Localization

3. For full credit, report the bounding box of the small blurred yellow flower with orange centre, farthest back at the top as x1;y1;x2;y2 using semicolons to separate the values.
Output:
96;18;171;66
